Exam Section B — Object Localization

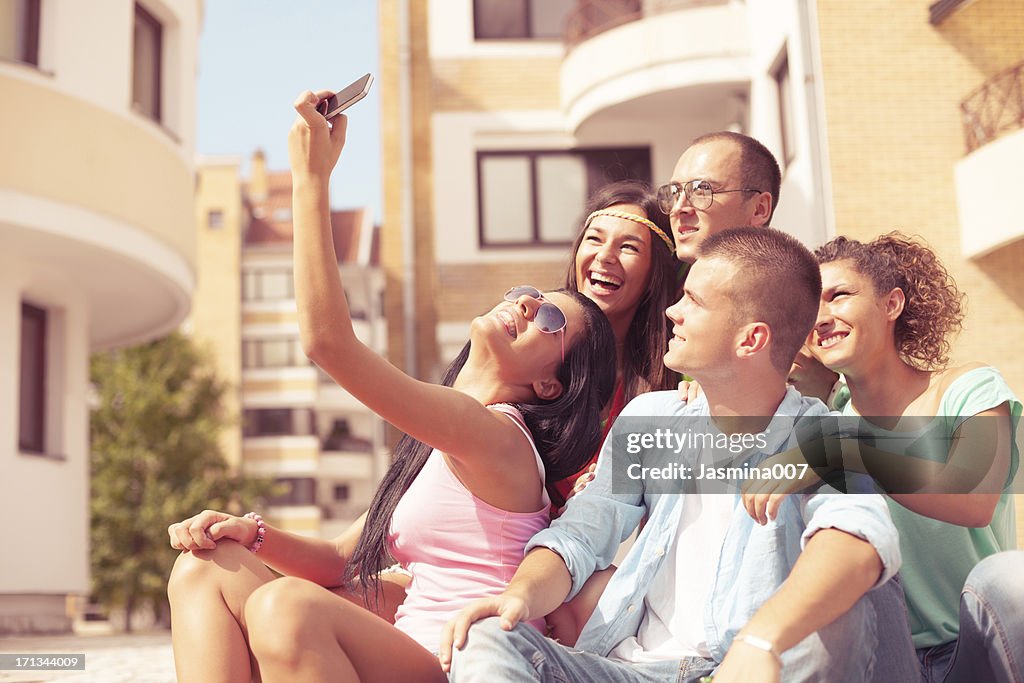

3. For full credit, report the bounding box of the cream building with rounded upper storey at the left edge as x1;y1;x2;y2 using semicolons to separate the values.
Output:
0;0;203;634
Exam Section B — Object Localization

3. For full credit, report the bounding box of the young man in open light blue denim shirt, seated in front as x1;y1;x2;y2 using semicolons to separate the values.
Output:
440;228;912;683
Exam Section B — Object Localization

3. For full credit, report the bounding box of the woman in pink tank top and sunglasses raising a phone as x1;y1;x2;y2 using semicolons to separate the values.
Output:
169;93;614;682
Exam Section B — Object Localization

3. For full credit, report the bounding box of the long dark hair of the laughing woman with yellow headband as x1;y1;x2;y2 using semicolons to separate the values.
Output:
565;180;679;403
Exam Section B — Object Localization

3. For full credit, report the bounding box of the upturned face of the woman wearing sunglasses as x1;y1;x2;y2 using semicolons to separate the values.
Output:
470;292;586;397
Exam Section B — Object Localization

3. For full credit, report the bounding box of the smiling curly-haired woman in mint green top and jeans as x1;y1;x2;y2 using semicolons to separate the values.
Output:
810;233;1024;682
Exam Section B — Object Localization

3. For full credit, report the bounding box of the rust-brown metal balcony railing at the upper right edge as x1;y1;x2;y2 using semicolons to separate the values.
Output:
961;61;1024;154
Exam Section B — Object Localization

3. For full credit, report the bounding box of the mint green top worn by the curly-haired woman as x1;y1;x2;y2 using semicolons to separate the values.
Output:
843;367;1022;648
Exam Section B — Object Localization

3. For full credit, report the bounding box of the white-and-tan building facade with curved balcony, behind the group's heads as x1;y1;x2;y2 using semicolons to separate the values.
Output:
380;0;831;378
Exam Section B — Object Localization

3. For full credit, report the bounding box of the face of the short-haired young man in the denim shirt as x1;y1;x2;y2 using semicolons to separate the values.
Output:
665;257;740;382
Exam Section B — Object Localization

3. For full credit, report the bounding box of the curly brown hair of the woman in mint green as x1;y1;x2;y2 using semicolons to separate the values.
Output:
814;231;965;370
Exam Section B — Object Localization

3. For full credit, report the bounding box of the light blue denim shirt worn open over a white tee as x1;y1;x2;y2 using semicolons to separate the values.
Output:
526;388;900;661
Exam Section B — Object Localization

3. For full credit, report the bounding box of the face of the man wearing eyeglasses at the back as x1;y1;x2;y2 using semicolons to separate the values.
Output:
669;139;771;263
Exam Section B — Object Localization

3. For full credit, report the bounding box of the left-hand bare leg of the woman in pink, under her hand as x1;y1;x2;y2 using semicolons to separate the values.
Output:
167;541;274;683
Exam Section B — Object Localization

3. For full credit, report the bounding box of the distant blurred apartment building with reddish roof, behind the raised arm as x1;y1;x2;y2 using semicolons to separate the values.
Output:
191;152;389;538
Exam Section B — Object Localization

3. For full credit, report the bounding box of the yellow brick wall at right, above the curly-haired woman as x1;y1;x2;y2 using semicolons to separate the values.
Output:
817;0;1024;544
